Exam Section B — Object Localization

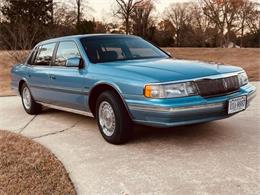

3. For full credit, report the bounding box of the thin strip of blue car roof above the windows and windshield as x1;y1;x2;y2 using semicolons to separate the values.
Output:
37;34;136;45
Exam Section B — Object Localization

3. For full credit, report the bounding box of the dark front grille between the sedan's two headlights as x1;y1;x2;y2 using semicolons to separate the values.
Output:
196;76;239;97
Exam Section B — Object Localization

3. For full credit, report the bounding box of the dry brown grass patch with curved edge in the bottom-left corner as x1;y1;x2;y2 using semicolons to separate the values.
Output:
0;131;76;194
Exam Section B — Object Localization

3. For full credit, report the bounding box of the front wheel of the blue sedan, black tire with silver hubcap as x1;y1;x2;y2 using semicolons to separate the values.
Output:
96;91;132;144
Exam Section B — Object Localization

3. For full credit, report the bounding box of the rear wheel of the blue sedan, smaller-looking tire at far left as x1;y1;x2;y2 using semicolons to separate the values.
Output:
21;83;42;115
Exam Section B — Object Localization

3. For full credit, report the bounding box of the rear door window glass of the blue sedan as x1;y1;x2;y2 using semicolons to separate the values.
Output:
33;43;56;66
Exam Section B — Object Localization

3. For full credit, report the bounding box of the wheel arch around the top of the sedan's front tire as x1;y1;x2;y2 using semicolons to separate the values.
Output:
88;82;133;119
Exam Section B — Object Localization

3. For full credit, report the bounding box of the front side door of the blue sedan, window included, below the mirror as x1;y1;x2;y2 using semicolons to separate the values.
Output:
49;41;87;110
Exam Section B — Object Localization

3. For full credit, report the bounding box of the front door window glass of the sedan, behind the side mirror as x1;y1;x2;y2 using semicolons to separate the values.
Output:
54;41;80;66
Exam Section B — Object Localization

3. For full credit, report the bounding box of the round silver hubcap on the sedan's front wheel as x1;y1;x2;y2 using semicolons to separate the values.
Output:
98;101;116;137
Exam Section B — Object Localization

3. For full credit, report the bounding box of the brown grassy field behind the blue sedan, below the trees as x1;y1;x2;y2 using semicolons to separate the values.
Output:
0;48;260;96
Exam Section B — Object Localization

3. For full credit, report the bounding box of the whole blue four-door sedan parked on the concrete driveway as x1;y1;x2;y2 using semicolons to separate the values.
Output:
11;34;256;144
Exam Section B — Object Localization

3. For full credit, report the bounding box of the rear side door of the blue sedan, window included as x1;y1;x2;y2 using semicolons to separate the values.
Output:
27;43;56;103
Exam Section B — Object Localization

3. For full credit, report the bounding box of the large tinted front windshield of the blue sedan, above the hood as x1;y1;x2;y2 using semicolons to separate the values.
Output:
81;36;169;63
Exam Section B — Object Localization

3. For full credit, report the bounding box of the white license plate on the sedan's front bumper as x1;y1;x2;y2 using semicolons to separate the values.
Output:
228;96;247;114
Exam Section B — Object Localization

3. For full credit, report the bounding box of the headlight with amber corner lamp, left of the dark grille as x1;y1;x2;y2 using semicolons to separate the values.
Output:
144;82;198;98
